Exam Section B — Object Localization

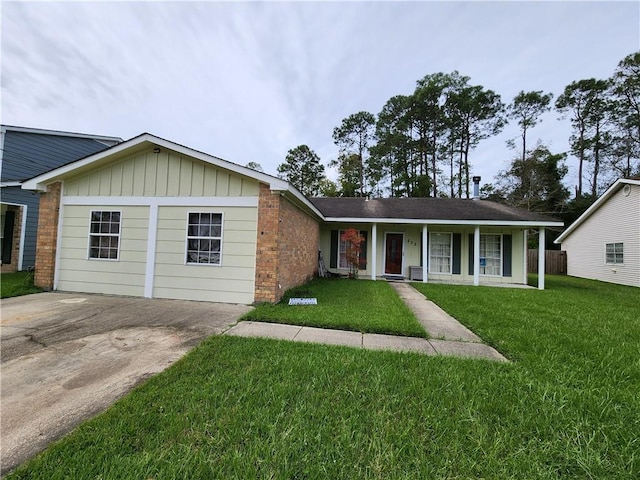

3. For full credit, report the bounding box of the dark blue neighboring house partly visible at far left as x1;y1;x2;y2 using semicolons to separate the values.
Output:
0;125;122;272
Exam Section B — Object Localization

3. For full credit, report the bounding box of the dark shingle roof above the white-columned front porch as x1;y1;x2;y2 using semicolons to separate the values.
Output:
310;198;559;222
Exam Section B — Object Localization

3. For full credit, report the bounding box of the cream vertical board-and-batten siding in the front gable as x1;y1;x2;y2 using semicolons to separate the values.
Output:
64;150;258;197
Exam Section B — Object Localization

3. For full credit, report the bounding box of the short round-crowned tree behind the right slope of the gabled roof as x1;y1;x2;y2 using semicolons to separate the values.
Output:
278;145;325;197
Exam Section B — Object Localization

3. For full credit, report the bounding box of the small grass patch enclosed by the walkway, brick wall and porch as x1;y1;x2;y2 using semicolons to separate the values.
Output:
242;278;426;337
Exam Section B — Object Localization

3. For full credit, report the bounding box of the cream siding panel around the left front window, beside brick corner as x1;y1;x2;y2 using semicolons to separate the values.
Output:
57;204;149;296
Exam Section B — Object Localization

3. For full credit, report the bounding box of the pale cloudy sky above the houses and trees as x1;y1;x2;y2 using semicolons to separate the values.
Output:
0;1;640;193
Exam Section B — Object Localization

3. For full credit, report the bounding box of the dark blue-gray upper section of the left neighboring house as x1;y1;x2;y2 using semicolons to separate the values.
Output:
1;128;120;182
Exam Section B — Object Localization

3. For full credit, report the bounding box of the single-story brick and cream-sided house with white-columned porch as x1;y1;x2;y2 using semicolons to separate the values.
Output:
23;133;562;303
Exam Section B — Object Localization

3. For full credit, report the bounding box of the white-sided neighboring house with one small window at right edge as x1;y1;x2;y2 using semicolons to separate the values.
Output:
555;178;640;287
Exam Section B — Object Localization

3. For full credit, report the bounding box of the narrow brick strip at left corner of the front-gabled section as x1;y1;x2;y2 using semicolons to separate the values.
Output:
34;182;62;290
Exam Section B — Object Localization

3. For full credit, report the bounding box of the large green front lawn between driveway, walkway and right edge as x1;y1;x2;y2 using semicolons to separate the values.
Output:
7;277;640;480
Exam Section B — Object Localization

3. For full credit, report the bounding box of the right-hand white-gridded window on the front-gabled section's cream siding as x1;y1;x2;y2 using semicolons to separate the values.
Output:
186;212;222;265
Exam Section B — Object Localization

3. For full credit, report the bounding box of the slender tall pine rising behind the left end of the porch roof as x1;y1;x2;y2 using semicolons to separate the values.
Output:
332;112;381;197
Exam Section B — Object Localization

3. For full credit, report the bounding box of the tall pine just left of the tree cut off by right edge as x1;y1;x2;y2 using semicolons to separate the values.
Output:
556;78;611;197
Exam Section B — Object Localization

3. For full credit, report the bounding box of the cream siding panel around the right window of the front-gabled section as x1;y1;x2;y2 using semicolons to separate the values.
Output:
153;206;258;303
